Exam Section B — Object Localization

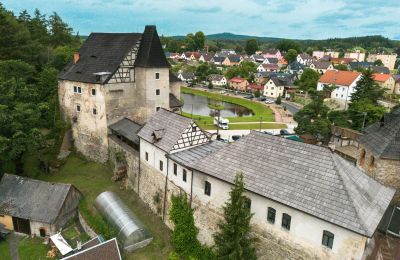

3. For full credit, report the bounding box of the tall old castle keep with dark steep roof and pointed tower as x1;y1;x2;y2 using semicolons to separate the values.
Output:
58;26;180;162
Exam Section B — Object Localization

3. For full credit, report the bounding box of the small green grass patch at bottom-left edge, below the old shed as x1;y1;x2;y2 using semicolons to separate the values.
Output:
18;237;50;260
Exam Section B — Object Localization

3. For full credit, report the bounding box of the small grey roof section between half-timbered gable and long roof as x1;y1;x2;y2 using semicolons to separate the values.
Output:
169;140;228;166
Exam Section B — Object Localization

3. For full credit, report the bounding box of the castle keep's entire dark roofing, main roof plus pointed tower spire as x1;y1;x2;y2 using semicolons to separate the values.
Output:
59;26;170;84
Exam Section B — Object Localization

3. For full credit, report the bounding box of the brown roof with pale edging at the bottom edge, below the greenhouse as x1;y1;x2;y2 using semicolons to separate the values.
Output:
63;238;122;260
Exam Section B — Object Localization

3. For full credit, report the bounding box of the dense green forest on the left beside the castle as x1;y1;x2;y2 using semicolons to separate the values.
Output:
0;3;81;177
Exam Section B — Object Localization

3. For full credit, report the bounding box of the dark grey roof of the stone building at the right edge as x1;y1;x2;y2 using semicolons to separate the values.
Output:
359;108;400;160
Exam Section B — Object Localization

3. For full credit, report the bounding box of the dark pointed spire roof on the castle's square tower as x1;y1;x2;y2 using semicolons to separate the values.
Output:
135;25;170;68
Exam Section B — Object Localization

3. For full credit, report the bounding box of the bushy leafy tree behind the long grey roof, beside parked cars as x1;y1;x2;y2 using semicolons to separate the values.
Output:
294;91;331;142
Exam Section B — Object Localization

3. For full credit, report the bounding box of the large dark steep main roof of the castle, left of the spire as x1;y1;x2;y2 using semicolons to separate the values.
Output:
59;33;141;84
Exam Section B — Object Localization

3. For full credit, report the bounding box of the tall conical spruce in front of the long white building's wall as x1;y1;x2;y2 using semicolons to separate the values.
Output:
214;173;257;259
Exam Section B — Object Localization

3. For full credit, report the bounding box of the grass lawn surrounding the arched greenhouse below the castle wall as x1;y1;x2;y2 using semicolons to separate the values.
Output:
33;154;172;259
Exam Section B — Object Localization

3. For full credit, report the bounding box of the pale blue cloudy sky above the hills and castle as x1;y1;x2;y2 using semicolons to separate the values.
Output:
0;0;400;40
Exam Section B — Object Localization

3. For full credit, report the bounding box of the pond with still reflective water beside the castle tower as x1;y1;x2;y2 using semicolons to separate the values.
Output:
181;93;254;117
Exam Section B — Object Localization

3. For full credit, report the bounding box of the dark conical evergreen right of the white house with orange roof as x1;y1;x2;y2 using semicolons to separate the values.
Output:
351;69;384;104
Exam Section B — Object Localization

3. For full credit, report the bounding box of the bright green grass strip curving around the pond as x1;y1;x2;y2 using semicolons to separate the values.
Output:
181;87;275;124
